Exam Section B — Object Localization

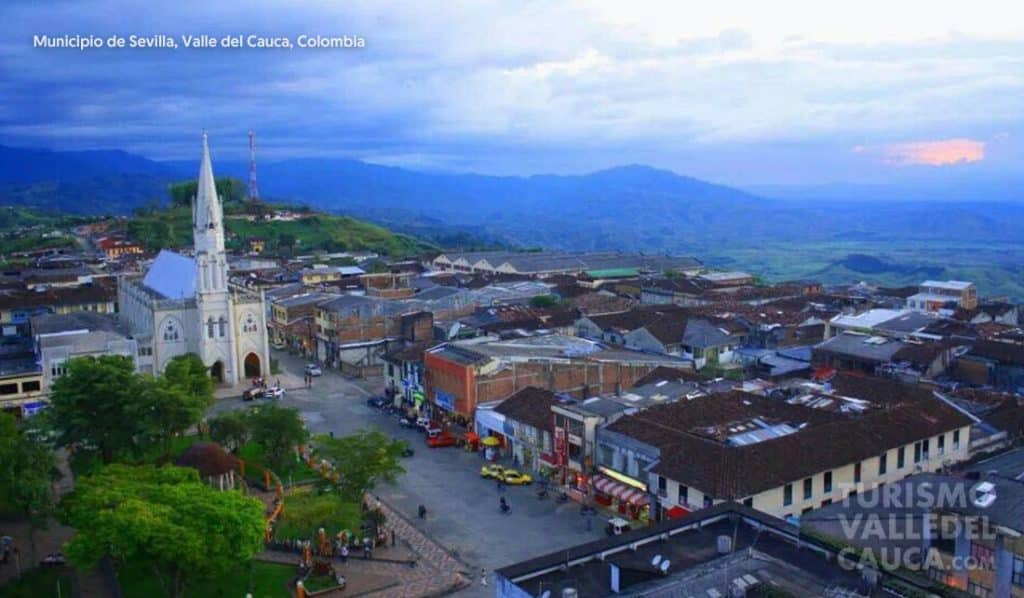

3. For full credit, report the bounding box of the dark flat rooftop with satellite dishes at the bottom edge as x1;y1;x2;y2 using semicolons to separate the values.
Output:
496;504;881;597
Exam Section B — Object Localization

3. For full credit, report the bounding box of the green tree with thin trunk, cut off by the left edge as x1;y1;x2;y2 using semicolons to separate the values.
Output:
0;413;56;562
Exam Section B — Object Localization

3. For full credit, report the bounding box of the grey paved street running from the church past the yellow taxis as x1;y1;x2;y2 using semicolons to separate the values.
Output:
213;352;603;596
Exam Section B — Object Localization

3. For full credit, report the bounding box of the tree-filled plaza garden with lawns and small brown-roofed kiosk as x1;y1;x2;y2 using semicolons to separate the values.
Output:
0;355;404;598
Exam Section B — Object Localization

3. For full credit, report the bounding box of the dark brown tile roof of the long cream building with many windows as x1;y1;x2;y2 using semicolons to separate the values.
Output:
608;376;971;500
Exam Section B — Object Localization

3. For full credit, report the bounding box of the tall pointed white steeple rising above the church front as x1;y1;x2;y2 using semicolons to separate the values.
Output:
193;131;227;293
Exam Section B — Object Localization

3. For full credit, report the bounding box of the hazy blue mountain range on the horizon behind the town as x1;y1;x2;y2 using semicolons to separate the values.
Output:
0;142;1024;296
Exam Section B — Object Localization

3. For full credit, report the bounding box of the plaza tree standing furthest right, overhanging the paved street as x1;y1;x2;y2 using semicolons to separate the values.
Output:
316;430;406;501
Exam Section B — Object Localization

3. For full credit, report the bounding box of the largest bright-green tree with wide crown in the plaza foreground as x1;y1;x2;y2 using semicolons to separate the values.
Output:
62;464;265;598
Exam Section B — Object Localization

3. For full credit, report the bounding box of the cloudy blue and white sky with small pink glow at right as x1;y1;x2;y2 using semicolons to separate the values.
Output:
0;0;1024;184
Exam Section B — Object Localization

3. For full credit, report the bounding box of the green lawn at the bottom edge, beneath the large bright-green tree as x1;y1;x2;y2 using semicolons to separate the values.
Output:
118;560;295;598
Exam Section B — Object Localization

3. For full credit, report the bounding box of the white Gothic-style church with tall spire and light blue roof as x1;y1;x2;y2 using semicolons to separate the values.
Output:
118;133;270;384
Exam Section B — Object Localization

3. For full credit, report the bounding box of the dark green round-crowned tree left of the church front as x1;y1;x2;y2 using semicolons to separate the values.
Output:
46;355;146;463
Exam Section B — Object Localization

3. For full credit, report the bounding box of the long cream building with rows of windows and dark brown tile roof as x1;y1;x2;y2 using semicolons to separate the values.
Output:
595;375;972;518
